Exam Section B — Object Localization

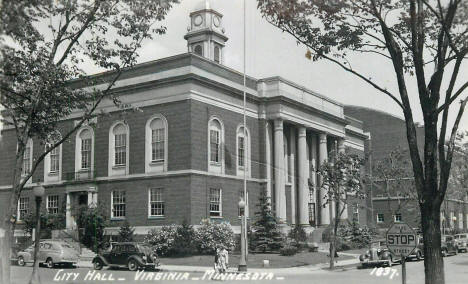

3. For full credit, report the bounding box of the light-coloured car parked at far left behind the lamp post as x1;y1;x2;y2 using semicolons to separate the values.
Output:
17;240;80;268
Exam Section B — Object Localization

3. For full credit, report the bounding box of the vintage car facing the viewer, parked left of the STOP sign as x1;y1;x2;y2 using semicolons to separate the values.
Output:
359;239;401;267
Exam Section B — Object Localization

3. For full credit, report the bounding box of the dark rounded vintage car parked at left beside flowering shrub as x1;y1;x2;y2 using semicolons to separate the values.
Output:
93;242;159;271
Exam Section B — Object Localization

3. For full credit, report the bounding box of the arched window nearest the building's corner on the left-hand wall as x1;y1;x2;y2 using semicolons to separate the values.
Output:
145;115;168;172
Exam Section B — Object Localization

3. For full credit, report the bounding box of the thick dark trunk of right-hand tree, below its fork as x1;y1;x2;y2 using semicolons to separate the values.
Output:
421;202;445;284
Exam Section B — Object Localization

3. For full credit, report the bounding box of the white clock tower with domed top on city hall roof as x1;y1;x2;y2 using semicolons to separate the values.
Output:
184;0;228;64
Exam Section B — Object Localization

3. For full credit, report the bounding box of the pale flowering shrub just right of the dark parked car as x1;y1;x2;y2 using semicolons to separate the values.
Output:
144;225;177;256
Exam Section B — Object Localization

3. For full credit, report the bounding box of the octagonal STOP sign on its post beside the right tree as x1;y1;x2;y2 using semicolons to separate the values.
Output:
387;223;417;284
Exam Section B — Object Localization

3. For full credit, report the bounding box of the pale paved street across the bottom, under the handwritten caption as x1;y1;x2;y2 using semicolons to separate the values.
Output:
13;253;468;284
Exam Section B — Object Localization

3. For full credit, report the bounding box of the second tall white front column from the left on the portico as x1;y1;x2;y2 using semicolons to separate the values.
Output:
297;126;309;226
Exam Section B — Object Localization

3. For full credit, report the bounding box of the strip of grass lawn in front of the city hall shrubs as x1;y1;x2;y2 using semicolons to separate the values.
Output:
160;252;352;268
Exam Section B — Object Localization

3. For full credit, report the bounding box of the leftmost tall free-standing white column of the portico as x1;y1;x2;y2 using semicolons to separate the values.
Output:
274;119;286;223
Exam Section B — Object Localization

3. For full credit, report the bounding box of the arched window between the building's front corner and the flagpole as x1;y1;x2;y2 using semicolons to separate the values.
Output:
208;117;224;173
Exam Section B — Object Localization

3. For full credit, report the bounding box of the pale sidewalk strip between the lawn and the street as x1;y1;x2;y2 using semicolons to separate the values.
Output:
77;253;359;275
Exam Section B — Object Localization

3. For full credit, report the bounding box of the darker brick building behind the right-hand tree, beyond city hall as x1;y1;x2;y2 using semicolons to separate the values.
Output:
344;106;468;232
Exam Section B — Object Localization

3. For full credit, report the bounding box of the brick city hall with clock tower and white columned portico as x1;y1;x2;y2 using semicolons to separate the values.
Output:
0;3;370;234
